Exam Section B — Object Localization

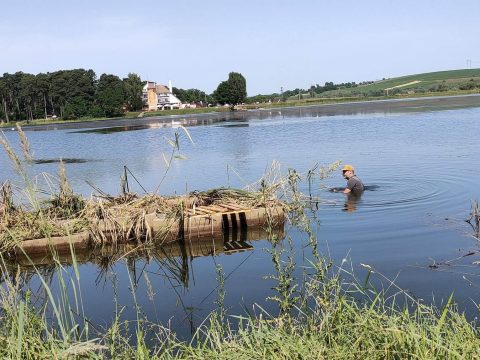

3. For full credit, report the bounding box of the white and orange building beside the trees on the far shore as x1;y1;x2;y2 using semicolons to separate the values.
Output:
142;81;182;111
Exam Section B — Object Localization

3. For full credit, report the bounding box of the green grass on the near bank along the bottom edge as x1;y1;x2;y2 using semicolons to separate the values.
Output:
0;258;480;359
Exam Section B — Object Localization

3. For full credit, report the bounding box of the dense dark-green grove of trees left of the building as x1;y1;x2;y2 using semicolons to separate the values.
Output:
0;69;144;122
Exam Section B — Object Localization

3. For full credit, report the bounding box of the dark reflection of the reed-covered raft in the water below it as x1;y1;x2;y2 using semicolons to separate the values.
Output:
13;225;285;288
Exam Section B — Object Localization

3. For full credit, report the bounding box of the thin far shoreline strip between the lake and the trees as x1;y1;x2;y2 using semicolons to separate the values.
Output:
0;94;480;131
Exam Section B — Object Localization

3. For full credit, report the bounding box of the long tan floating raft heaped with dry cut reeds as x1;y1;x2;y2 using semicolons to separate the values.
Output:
0;185;285;257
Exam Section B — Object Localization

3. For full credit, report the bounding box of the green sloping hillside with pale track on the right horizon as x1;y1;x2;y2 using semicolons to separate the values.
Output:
319;69;480;97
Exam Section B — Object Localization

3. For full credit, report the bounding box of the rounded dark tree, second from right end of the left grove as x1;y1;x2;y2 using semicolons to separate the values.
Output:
95;74;124;117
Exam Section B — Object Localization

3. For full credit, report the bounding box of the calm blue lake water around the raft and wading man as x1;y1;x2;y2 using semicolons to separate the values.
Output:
0;100;480;337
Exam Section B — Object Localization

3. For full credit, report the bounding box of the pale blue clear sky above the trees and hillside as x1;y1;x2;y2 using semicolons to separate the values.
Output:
0;0;480;96
